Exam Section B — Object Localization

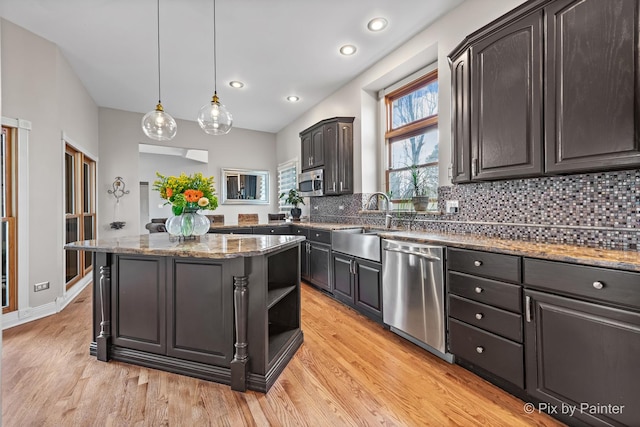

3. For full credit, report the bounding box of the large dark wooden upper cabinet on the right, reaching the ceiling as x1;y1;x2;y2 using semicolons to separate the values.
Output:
449;0;640;183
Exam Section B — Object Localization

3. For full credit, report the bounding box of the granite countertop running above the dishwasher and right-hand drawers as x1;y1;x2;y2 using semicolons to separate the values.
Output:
379;231;640;271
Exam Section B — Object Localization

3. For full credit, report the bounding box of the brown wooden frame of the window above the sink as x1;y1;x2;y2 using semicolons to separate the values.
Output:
384;68;439;203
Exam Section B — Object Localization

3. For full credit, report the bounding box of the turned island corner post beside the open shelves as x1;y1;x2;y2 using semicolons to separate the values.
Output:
231;276;249;391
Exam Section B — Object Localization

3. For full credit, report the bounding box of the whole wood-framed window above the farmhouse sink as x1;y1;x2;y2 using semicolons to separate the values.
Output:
385;70;438;206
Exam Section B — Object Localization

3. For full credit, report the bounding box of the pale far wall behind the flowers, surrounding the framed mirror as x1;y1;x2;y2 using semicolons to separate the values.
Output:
98;107;278;237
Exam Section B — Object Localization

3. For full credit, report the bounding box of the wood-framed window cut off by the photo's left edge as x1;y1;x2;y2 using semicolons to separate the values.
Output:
0;126;18;313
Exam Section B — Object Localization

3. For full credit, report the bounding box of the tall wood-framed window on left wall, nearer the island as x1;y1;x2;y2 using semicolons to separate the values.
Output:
64;144;96;289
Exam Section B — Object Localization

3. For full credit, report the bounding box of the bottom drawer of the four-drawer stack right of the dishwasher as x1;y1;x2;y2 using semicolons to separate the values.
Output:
449;319;524;388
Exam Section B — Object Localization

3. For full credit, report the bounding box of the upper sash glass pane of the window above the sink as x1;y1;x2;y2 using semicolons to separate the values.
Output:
391;80;438;129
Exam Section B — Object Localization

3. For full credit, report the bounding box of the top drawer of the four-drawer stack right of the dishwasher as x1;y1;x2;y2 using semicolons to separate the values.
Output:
447;248;520;283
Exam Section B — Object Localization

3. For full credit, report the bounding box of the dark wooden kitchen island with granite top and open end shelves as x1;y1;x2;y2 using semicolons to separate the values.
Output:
65;233;304;392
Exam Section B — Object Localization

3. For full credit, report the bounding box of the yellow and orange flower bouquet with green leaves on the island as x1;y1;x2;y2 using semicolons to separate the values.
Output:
153;172;218;215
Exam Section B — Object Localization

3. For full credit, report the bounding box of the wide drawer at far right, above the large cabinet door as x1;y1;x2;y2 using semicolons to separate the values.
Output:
524;258;640;309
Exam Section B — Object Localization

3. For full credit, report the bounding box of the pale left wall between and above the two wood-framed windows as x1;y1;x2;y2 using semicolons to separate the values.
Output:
1;20;98;314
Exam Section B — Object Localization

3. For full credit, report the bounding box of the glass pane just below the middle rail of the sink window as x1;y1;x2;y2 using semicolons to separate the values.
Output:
389;126;438;169
